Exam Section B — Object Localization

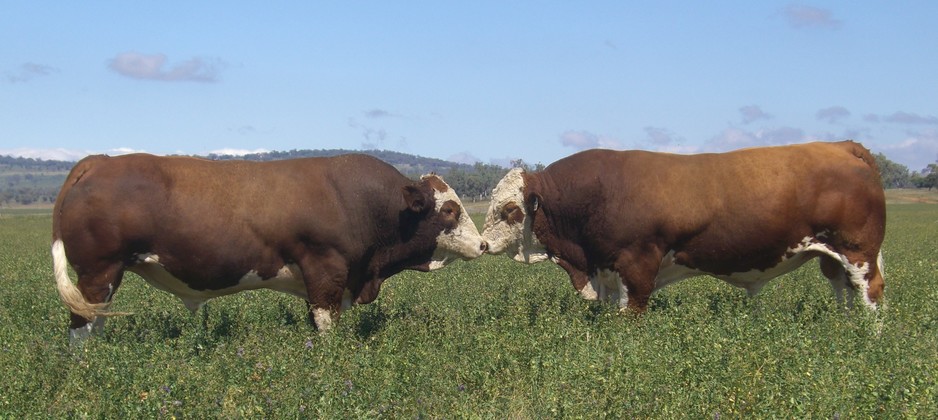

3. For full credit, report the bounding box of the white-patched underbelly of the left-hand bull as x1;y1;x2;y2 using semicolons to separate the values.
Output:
128;254;308;311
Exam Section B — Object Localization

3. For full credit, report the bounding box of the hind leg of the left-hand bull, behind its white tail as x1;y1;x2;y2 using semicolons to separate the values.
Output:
68;264;124;343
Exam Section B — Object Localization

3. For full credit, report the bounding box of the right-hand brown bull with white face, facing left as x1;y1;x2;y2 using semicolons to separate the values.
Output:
482;141;886;311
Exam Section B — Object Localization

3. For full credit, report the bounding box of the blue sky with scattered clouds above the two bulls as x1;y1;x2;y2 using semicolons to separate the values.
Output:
0;0;938;170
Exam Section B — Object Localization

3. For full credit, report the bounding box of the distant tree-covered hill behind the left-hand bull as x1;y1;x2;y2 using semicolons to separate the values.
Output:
0;149;503;207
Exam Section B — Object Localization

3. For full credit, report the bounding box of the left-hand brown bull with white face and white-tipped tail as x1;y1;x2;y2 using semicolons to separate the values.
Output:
52;154;486;339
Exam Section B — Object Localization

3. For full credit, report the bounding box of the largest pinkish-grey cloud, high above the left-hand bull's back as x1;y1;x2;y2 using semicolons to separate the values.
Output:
108;52;224;83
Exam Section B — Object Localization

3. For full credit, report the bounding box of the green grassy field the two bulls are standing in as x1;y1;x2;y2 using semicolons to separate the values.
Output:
0;204;938;419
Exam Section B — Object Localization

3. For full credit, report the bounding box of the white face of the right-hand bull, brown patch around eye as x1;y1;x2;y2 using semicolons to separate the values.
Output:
482;168;547;264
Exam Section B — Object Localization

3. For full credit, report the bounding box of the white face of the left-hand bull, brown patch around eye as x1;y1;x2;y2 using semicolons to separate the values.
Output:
421;175;482;270
